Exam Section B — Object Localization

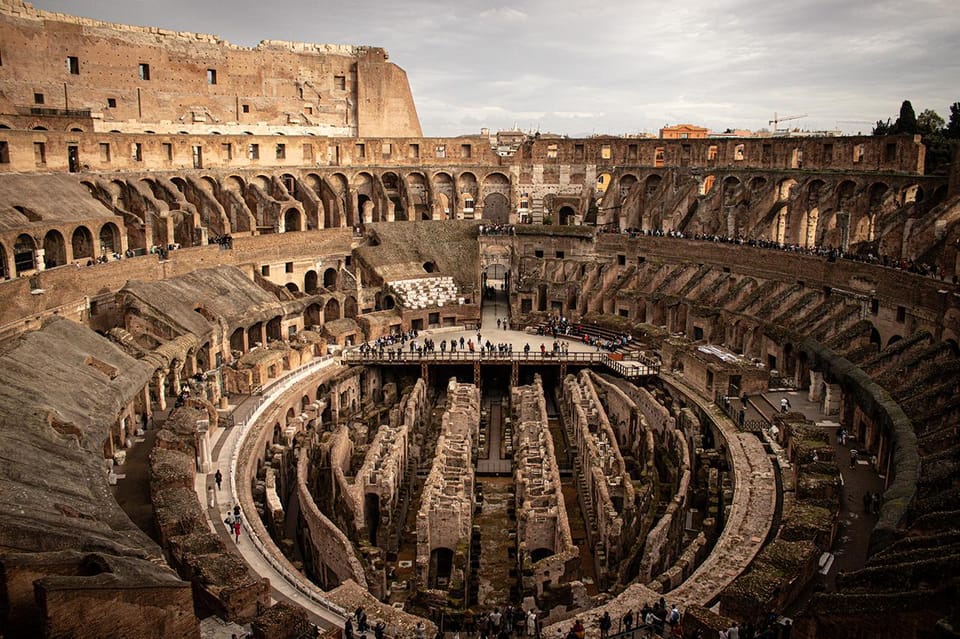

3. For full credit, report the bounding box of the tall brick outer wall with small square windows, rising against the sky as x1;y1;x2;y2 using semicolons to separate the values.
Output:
0;0;420;135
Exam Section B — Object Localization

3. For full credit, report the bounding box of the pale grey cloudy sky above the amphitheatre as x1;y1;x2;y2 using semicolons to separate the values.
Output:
33;0;960;136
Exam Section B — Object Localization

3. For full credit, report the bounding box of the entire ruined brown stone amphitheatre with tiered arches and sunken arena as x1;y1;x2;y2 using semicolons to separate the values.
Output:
0;0;960;639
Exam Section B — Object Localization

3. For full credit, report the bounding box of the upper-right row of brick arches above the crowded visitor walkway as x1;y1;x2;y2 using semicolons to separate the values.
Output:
598;172;947;249
